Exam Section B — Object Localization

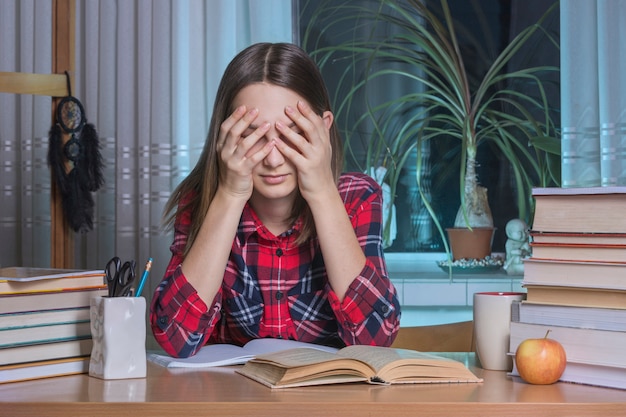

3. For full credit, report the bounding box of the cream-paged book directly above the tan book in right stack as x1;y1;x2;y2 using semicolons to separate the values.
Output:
522;256;626;291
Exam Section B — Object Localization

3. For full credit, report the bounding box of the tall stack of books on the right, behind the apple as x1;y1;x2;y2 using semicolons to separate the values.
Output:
510;187;626;389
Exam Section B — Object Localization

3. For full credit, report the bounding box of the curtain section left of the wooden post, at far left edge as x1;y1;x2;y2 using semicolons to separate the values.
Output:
0;0;52;266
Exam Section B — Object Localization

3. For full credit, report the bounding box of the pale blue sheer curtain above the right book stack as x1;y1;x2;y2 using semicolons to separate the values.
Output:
561;0;626;187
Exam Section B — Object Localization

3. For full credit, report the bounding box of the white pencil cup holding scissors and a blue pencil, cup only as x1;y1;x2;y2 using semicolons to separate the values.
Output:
89;297;146;379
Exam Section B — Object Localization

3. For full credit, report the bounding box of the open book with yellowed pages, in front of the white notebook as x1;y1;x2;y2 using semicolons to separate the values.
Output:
237;345;482;388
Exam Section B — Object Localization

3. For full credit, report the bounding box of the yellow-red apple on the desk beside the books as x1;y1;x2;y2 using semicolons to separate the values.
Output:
515;330;566;385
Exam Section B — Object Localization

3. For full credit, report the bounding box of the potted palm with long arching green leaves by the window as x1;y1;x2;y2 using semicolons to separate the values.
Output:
302;0;560;259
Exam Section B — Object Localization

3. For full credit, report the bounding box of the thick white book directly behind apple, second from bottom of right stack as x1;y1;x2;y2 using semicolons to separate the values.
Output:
509;321;626;368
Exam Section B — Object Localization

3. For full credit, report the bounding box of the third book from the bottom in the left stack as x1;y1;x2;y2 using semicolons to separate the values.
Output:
0;320;91;349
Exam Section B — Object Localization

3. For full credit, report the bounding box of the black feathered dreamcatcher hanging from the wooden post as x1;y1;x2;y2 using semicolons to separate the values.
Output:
48;73;104;232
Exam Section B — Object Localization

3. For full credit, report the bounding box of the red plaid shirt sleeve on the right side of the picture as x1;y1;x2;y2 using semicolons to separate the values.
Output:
329;175;400;346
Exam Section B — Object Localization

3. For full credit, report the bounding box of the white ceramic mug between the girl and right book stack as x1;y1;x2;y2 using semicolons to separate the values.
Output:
474;292;526;371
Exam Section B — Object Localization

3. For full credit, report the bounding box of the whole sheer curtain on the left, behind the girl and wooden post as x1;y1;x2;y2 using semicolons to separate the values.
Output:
0;0;292;295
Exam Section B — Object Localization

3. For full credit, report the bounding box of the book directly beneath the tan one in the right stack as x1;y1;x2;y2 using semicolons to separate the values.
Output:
511;301;626;332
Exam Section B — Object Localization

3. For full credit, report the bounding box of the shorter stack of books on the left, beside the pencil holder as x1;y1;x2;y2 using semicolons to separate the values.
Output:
0;268;107;383
